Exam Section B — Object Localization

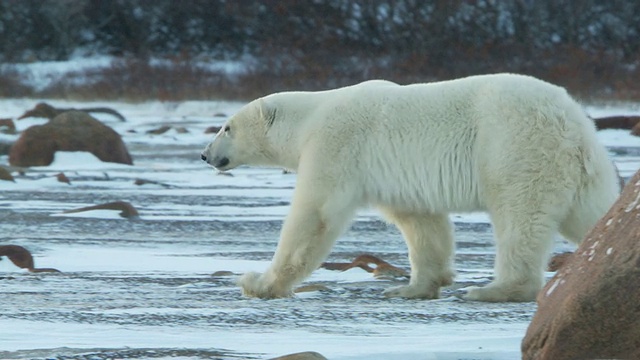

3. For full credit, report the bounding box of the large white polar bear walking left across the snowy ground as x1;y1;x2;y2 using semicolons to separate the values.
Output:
201;74;618;302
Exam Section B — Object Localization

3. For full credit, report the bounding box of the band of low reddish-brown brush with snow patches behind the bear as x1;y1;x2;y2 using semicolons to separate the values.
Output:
5;50;640;102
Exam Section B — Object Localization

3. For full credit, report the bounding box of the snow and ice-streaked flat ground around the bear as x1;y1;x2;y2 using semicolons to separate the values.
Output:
0;90;640;360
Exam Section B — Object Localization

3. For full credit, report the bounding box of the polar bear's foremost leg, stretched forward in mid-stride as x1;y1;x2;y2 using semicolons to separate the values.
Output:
238;176;356;299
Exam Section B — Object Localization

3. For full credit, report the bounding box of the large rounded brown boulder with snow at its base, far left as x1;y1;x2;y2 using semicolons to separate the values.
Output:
9;111;133;166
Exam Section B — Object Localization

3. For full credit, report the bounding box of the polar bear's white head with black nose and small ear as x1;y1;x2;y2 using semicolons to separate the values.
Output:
201;99;276;171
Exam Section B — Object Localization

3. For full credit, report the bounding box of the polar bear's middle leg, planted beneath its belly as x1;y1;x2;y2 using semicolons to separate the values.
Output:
383;210;455;299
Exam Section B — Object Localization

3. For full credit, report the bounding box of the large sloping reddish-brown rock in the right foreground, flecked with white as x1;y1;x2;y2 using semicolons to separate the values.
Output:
522;171;640;360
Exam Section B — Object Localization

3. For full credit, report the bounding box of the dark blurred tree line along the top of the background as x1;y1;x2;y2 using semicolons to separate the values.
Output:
0;0;640;98
